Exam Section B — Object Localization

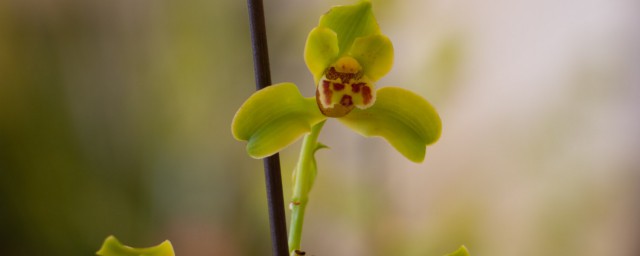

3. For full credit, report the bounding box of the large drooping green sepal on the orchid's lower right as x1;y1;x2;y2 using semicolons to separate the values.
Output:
338;87;442;162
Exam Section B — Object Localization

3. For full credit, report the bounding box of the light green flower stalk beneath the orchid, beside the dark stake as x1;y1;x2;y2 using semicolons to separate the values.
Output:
289;121;325;255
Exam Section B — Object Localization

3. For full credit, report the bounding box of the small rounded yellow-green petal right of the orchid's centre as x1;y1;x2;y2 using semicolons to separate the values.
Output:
349;34;393;81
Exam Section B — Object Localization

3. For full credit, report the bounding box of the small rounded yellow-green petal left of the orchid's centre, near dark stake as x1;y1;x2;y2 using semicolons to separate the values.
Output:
304;27;338;85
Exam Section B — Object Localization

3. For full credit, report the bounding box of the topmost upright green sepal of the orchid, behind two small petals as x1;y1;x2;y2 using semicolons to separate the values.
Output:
318;1;380;56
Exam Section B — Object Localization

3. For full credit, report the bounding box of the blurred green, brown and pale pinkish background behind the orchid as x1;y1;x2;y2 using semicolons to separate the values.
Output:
0;0;640;256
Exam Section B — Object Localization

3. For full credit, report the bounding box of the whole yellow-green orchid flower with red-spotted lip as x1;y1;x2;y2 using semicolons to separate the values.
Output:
232;1;441;162
